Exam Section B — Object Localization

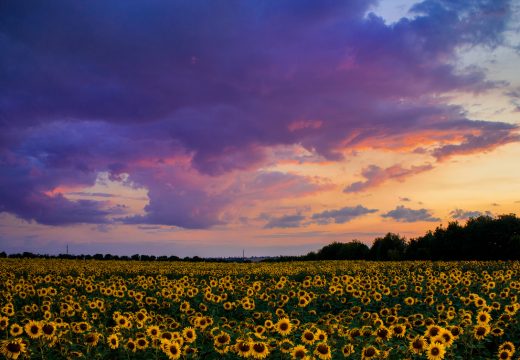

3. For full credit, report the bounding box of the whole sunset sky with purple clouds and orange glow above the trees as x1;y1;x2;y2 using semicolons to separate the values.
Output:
0;0;520;257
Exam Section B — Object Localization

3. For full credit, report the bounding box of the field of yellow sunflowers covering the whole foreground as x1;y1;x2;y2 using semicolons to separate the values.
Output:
0;259;520;360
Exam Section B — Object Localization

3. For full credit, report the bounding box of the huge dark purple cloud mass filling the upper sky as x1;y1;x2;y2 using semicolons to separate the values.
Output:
0;0;519;227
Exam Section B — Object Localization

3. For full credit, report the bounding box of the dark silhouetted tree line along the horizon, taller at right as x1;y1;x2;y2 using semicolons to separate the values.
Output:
0;214;520;262
